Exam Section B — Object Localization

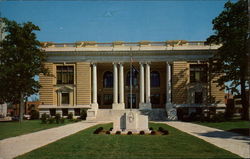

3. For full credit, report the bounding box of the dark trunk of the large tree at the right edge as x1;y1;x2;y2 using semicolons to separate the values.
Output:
240;77;249;120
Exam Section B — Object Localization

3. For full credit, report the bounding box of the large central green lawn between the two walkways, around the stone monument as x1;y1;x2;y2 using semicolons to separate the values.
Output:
17;123;240;159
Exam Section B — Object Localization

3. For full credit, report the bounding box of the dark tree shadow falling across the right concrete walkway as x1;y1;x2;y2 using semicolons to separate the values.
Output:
197;131;250;144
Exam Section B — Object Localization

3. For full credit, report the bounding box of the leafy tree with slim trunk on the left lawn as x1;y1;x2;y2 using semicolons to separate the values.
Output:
0;18;48;122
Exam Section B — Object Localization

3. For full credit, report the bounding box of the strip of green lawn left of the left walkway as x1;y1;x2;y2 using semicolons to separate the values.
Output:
0;120;73;140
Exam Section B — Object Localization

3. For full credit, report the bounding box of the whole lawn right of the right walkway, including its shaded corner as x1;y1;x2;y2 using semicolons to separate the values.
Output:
195;120;250;136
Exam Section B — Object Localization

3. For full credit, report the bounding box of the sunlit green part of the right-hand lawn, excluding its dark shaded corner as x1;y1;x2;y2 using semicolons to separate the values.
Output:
195;120;250;131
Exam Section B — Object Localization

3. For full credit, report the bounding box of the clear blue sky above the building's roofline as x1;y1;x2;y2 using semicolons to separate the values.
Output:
0;0;230;42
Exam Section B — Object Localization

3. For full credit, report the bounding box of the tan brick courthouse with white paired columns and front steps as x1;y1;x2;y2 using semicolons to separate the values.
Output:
39;40;225;120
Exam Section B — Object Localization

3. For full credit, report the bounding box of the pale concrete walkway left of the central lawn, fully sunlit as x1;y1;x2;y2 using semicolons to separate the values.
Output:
0;121;100;159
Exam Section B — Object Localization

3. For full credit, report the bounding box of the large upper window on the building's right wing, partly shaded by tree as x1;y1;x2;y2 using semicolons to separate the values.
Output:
190;64;207;83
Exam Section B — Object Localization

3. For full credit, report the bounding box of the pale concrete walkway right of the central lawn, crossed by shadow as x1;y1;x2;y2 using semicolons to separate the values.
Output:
157;121;250;158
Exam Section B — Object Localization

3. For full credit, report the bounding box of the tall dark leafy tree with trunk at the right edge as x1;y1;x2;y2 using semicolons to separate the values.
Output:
207;0;249;119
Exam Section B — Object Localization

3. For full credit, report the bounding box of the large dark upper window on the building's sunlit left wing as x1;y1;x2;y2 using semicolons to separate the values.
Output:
56;66;74;84
